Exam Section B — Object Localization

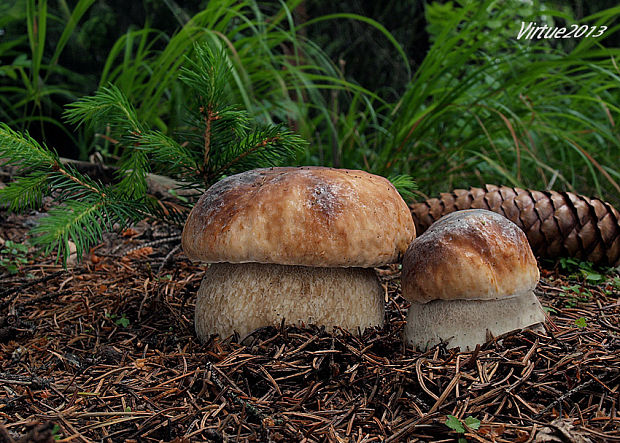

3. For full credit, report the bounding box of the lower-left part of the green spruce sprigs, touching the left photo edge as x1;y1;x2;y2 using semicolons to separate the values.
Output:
0;125;146;264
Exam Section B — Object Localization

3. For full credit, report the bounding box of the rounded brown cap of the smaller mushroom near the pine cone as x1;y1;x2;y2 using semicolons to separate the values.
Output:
402;209;540;303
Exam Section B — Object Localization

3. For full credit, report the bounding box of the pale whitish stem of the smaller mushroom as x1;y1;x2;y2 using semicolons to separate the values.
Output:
404;292;545;351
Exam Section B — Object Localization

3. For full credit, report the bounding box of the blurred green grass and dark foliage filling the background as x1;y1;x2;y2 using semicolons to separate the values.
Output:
0;0;620;205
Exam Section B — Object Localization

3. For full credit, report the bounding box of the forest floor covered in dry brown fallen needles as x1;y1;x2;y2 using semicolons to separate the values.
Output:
0;199;620;442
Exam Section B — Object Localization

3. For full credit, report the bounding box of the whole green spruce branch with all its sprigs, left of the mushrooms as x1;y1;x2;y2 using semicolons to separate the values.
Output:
0;45;305;263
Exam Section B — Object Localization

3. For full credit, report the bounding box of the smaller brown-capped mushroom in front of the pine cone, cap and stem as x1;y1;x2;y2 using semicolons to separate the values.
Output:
402;209;545;351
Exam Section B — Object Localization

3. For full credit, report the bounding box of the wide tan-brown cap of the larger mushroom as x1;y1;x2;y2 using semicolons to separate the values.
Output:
183;167;415;267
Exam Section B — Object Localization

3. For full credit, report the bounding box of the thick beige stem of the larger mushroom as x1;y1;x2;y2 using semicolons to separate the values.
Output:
195;263;384;341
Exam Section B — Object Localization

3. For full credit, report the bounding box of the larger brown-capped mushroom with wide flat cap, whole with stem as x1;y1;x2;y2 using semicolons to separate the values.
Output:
183;167;415;340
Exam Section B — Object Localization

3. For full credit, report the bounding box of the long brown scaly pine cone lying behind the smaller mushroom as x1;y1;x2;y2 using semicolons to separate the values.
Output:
410;185;620;266
